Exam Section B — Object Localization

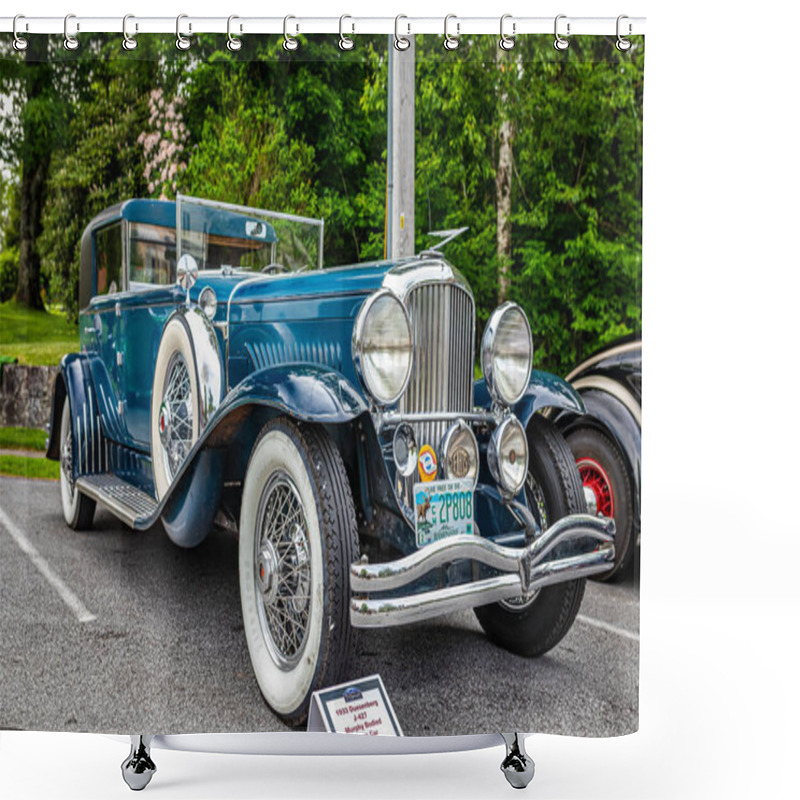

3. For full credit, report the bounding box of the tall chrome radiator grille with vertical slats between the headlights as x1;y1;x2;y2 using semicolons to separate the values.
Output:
399;283;475;457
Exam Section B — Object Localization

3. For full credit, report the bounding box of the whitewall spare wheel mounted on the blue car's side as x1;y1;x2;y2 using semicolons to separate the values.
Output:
150;316;200;499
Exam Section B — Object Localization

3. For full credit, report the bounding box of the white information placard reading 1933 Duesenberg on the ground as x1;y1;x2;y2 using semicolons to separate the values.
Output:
308;675;403;736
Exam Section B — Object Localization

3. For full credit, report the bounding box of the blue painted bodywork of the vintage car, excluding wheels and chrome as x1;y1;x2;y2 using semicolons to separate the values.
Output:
48;200;584;556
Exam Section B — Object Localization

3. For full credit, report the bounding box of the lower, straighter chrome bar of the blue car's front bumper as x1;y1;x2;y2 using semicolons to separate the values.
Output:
350;544;614;628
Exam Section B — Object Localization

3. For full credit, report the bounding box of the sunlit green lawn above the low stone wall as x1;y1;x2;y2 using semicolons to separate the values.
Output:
0;301;79;366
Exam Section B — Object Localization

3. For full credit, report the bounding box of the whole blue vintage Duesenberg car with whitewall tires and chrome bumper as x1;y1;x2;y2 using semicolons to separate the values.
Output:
48;197;614;724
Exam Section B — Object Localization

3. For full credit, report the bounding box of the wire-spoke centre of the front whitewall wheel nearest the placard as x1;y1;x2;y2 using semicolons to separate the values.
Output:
255;470;311;670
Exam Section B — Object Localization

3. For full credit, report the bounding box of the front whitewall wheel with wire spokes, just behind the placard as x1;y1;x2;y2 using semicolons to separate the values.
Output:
239;418;358;725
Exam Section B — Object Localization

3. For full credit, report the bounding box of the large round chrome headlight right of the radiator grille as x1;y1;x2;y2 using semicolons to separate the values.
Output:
481;303;533;406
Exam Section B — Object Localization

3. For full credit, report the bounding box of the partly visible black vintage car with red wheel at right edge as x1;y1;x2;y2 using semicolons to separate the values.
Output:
556;335;642;580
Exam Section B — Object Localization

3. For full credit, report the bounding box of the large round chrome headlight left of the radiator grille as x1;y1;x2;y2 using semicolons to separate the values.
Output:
353;289;413;406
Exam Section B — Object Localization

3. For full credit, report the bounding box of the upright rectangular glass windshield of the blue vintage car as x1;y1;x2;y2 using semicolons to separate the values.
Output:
176;195;324;272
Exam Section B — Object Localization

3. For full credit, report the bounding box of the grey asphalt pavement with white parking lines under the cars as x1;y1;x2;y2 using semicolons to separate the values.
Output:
0;477;639;736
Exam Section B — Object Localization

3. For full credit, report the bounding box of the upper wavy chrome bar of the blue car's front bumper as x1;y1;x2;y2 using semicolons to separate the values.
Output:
350;514;614;594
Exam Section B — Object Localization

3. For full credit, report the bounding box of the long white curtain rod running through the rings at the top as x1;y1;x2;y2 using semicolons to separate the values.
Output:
0;15;646;36
